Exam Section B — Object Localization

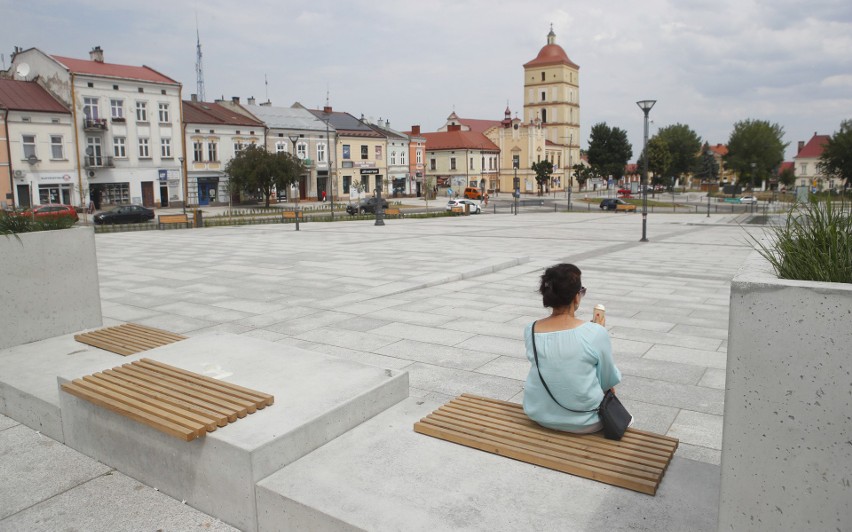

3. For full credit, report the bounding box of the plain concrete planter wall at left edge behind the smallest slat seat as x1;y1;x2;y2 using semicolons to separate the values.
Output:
0;227;103;349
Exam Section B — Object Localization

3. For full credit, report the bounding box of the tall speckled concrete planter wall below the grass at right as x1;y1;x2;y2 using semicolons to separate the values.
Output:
719;253;852;531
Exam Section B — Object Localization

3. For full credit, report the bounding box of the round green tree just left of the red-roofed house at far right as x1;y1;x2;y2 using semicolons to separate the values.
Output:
725;119;787;188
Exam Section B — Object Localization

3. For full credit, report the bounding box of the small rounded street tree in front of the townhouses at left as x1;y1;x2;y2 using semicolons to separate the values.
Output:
225;144;305;207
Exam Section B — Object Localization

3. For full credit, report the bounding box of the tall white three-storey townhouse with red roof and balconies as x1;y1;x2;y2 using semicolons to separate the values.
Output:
12;47;184;208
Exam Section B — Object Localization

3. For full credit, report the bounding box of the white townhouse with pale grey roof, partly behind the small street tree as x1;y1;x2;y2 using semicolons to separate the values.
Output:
236;98;340;200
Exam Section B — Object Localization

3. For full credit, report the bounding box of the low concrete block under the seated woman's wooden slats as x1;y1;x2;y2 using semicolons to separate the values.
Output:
256;398;719;532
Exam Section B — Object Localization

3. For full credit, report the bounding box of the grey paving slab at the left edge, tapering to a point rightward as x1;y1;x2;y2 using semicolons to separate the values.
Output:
0;425;110;520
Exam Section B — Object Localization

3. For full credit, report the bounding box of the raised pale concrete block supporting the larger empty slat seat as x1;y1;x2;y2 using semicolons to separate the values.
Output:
59;333;408;530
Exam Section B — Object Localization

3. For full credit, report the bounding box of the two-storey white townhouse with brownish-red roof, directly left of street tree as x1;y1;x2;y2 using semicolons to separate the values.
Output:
183;94;264;205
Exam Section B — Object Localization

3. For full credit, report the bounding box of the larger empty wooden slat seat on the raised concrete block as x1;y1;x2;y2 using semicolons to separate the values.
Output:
62;358;275;441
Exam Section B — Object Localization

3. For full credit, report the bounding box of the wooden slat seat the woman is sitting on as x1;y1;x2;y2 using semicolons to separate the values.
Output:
414;394;678;495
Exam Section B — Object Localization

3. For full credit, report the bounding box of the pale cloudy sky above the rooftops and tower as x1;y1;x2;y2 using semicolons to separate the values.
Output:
0;0;852;159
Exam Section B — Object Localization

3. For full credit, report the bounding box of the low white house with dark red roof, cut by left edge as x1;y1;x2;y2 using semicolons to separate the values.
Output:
0;79;75;208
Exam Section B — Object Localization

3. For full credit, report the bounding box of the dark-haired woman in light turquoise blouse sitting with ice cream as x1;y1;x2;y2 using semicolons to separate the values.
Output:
524;264;621;434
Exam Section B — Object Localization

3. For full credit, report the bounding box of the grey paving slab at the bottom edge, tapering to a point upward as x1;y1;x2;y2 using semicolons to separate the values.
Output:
0;468;237;532
